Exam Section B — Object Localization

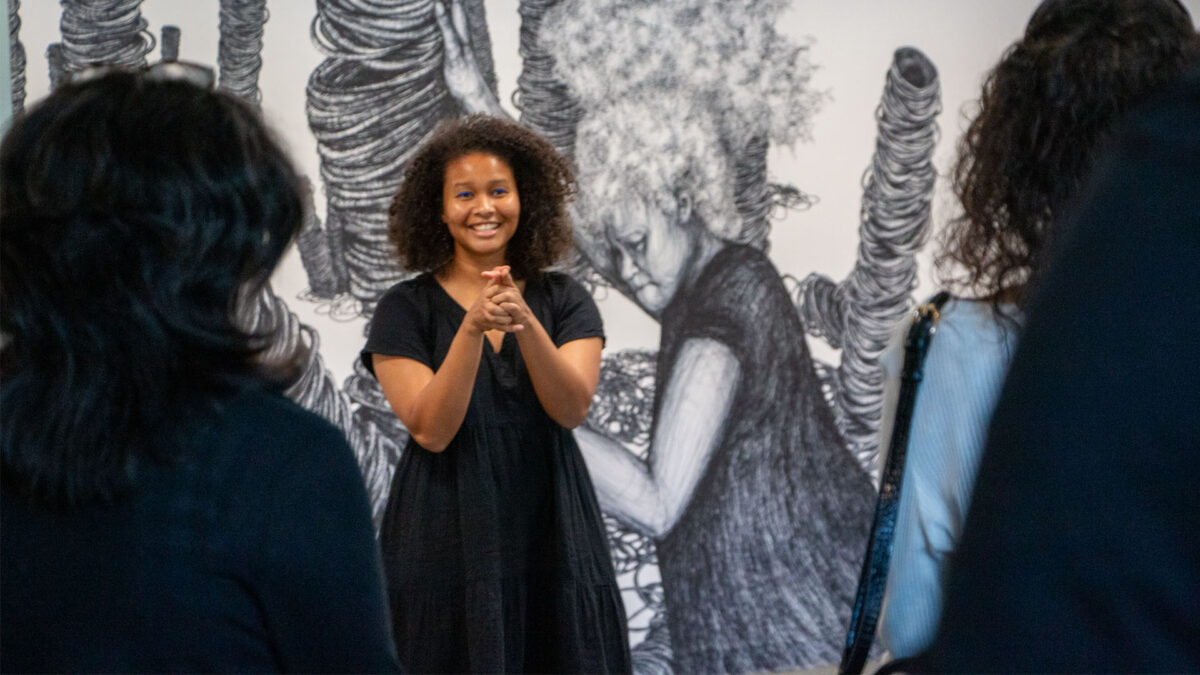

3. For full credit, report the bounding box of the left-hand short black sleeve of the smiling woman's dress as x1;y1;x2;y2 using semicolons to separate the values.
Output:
360;279;433;375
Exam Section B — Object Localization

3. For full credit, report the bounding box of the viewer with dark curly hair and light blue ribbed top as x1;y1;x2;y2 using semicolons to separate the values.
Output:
880;0;1195;657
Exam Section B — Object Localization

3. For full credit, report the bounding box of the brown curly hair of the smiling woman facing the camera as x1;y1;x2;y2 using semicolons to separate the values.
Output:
388;115;576;279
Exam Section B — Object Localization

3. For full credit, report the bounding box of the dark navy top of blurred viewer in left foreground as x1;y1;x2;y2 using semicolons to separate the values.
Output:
0;381;397;673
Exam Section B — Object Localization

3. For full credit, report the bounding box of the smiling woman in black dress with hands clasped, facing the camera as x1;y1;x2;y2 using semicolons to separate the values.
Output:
362;115;630;673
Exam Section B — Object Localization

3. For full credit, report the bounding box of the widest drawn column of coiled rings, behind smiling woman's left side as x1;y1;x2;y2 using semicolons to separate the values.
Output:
307;0;496;311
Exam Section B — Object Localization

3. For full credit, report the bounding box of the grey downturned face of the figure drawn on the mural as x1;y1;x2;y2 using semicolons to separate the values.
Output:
607;194;696;317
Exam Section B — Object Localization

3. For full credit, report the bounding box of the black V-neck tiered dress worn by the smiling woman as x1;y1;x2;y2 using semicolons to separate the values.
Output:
362;273;630;673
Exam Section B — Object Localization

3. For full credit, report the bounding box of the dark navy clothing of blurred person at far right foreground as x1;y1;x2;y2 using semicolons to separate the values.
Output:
923;72;1200;673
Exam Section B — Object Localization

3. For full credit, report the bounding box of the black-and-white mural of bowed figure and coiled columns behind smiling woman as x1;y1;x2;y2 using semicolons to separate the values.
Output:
8;0;942;673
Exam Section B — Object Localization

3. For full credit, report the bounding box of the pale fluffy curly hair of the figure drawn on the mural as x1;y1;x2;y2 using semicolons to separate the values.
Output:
540;0;827;250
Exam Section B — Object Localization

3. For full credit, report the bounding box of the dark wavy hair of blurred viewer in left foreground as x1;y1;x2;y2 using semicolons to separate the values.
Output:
0;72;302;506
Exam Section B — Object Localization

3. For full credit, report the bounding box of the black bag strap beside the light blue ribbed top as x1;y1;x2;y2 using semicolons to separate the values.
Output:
838;291;950;675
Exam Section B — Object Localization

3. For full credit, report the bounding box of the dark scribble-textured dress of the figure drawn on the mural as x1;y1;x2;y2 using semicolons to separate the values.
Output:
655;245;875;673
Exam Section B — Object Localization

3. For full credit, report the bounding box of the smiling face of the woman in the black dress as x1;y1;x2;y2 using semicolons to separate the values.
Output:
442;153;521;258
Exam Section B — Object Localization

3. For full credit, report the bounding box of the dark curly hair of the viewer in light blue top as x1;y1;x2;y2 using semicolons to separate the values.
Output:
937;0;1196;309
